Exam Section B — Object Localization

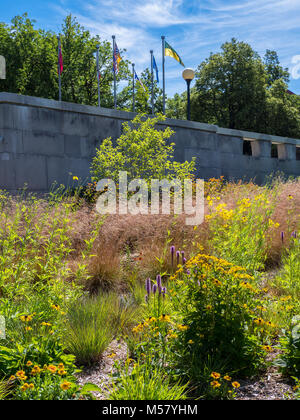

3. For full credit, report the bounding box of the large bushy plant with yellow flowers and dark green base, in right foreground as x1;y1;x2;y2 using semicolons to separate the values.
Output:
172;254;272;384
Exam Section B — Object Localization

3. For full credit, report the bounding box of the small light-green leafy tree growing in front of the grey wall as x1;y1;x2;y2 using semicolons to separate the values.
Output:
91;115;195;182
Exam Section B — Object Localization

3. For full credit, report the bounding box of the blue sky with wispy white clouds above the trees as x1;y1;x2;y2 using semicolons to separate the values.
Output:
0;0;300;97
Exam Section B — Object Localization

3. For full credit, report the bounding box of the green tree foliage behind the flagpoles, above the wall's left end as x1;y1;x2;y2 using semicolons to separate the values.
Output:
0;13;129;108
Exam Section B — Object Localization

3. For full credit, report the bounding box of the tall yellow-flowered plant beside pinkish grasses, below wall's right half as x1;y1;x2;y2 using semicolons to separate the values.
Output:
206;190;279;272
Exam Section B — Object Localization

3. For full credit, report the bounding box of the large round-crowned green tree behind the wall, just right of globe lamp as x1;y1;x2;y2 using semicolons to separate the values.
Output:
192;39;267;131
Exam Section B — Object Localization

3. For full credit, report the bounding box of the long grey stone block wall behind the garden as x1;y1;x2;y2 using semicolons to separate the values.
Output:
0;93;300;191
